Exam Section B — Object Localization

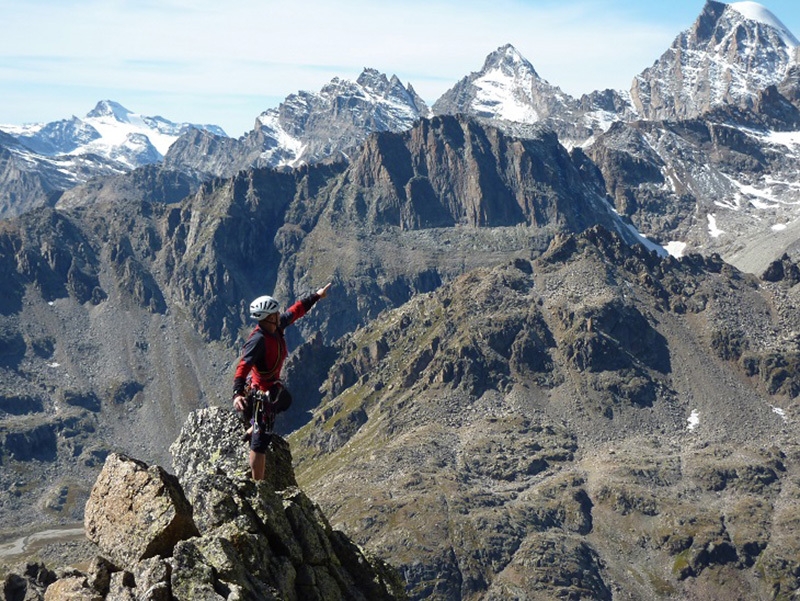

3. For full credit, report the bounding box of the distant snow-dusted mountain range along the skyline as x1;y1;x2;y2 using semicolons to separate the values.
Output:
0;1;800;216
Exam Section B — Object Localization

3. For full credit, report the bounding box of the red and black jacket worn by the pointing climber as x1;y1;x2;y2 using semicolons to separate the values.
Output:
233;294;320;396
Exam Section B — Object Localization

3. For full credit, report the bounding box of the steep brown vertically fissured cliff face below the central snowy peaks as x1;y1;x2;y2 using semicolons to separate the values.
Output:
344;117;633;236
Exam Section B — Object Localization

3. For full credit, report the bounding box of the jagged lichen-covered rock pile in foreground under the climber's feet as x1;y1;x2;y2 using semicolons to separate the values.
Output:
4;408;406;601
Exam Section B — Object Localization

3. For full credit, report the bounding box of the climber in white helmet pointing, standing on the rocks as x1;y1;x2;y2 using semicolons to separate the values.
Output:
233;283;331;480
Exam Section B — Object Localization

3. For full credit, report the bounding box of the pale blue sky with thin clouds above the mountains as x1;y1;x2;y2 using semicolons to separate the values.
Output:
0;0;800;136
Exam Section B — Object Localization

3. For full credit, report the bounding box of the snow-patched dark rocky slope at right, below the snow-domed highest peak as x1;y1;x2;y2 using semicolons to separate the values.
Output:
585;92;800;273
